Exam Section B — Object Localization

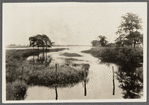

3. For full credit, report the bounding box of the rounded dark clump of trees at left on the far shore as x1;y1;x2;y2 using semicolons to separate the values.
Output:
29;34;53;49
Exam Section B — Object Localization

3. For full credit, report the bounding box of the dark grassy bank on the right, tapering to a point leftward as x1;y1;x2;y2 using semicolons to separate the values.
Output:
82;47;143;65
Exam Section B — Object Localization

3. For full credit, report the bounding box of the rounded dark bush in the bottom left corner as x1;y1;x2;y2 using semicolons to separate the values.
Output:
6;80;27;100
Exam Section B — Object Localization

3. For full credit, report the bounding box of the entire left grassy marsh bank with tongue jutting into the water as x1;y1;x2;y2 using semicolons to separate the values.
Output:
6;49;89;100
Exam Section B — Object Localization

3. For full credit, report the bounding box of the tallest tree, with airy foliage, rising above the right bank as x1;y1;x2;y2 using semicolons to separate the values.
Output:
116;13;143;47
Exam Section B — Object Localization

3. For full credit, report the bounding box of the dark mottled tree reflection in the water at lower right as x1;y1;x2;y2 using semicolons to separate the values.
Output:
117;66;143;98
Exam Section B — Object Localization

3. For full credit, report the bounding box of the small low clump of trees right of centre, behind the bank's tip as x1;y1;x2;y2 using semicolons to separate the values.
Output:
91;35;108;47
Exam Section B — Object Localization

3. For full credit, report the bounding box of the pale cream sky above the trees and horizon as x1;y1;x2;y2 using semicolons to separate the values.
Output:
2;2;147;45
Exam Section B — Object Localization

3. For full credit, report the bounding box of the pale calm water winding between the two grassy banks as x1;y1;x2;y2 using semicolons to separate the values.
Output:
25;46;123;100
